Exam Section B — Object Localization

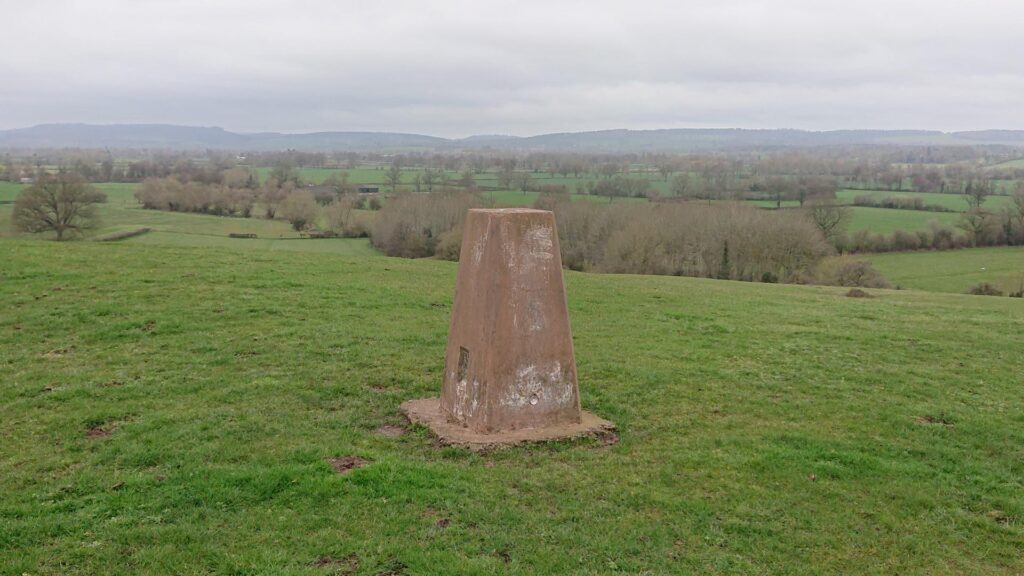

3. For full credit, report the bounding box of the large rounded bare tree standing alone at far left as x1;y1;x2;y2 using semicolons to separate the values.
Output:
11;172;106;240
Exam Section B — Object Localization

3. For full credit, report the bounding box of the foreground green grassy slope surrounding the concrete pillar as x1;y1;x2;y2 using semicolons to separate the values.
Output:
0;241;1024;574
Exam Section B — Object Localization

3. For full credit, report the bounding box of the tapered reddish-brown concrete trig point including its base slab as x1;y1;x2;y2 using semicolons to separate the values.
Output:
401;209;614;448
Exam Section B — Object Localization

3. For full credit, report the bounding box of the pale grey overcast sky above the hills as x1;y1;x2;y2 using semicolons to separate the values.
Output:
0;0;1024;136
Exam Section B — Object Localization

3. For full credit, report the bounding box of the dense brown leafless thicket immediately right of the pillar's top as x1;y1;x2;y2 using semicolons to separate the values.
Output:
555;202;831;282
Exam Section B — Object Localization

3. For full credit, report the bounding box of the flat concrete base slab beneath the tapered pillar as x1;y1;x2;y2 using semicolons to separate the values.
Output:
400;398;618;450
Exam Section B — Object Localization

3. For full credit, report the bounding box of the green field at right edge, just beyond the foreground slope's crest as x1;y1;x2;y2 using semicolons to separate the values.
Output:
865;247;1024;293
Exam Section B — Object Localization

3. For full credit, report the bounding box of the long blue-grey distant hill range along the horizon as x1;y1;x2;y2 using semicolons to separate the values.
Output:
0;124;1024;153
